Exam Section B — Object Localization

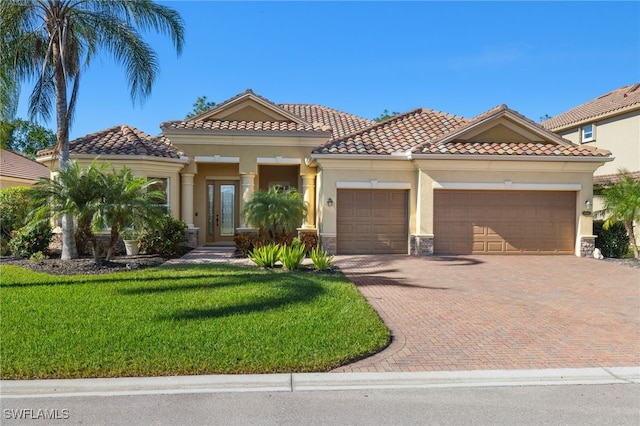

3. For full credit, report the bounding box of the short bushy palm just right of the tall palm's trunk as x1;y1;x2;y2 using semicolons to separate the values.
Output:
95;166;166;260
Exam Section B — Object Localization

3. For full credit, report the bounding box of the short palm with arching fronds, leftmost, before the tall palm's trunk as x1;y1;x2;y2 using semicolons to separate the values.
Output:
34;161;106;258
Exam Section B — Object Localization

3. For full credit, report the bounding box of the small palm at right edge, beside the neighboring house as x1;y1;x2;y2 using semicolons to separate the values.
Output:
597;169;640;259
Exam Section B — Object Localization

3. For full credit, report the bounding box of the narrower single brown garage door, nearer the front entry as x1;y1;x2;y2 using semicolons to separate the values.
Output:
336;189;409;254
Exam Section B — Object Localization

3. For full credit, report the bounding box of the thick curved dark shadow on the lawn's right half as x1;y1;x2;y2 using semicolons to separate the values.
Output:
157;277;325;321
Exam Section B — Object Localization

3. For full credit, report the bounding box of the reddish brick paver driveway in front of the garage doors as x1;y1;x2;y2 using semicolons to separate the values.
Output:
335;255;640;372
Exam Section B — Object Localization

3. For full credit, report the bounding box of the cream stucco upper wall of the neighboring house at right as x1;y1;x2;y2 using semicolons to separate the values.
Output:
559;110;640;176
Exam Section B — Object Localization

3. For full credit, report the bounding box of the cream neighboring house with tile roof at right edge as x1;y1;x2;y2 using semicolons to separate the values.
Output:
541;83;640;243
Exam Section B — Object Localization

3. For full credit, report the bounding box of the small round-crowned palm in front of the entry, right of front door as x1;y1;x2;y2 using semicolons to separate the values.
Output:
242;185;307;242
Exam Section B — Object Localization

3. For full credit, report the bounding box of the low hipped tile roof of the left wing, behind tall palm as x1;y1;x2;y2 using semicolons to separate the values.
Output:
38;125;182;158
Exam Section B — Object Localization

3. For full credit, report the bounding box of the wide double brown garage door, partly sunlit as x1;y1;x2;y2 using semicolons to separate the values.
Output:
433;190;576;254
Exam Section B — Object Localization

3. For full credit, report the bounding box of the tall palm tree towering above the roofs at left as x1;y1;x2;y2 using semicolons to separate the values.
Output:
0;0;184;259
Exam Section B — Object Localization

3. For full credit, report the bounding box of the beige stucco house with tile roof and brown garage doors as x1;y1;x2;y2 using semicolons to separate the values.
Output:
39;90;610;256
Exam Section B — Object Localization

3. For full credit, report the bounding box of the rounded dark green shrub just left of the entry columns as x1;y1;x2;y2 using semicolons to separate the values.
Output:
140;215;187;257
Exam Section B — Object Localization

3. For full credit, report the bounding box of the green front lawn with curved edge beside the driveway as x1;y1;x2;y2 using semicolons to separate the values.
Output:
0;264;390;379
